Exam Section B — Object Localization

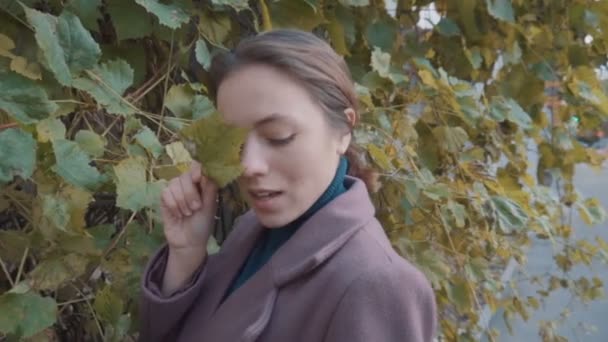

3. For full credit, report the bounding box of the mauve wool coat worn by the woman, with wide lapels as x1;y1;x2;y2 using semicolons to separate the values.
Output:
140;177;437;342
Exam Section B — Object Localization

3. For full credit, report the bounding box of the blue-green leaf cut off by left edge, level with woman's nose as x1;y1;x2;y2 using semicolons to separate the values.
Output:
0;128;36;184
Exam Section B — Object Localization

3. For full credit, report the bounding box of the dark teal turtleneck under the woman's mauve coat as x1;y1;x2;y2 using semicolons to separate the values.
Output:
225;157;348;297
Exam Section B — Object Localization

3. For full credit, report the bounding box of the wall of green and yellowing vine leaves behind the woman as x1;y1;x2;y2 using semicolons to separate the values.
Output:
0;0;608;341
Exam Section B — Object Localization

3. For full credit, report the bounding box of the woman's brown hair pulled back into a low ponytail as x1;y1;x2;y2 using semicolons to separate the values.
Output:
209;29;378;192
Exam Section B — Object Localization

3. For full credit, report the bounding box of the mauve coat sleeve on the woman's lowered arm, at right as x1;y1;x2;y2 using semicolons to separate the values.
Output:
325;264;437;342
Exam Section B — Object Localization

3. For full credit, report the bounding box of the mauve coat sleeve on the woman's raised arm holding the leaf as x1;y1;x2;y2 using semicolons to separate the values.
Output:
138;245;210;342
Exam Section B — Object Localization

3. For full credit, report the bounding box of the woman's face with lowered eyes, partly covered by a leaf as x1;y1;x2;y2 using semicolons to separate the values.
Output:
217;64;350;228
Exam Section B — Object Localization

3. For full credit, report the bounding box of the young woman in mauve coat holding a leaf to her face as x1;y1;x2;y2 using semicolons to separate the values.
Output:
140;30;437;342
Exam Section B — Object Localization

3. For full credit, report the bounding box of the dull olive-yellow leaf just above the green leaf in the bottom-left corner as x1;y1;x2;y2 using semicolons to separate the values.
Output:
29;254;88;290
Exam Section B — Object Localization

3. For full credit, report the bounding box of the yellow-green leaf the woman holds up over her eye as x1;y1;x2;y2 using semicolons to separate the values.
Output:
181;111;247;187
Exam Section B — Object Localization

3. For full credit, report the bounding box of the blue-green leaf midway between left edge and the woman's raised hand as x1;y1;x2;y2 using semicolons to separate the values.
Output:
53;139;105;190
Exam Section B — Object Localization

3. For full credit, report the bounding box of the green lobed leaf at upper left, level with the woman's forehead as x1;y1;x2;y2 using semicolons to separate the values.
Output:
74;59;135;115
